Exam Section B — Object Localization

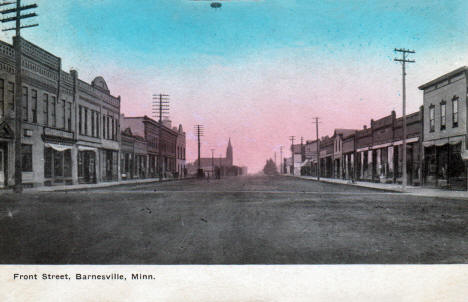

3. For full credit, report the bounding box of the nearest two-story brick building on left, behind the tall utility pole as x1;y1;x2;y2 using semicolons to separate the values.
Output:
0;39;76;187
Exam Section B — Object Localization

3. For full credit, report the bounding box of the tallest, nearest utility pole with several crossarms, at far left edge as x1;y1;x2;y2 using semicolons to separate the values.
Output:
0;0;39;193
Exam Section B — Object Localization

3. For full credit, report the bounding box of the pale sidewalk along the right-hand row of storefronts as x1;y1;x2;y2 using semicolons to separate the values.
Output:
287;175;468;200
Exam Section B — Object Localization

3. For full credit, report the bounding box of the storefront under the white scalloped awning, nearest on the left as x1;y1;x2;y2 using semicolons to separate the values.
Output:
44;143;73;186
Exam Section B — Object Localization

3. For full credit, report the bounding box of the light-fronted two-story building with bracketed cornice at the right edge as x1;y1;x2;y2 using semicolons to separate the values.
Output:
419;66;468;190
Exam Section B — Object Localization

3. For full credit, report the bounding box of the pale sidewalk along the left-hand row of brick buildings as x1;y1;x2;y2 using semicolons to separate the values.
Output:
0;177;191;194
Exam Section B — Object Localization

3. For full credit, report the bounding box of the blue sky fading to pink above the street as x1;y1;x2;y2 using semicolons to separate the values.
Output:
2;0;468;172
